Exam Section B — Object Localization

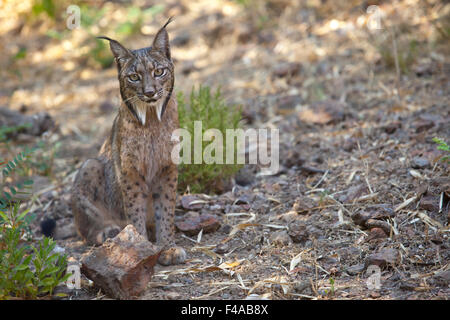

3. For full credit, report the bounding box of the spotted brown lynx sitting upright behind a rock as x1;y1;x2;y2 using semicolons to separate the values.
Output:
71;19;186;265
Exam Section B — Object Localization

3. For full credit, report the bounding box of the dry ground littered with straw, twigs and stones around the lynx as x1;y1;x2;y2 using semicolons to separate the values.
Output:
0;0;450;299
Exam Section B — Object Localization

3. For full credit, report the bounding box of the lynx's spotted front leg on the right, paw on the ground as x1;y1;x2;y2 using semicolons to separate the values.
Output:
152;165;186;265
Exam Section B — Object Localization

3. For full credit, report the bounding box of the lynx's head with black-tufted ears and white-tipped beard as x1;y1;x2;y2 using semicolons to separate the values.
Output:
99;18;174;125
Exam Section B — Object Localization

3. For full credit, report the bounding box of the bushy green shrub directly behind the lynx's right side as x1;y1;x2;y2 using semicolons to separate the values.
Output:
177;87;242;193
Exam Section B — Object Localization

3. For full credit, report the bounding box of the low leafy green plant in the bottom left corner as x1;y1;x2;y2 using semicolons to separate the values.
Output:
0;203;70;299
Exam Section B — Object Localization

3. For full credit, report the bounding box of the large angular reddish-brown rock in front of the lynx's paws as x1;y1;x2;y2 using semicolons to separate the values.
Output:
81;225;160;299
